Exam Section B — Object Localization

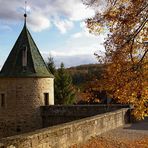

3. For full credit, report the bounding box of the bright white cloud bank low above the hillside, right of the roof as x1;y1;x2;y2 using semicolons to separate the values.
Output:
42;27;104;67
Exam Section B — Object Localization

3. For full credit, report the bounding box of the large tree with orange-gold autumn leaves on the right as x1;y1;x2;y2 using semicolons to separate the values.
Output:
84;0;148;119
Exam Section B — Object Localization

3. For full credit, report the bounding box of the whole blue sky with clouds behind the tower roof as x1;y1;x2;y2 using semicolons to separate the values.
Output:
0;0;104;67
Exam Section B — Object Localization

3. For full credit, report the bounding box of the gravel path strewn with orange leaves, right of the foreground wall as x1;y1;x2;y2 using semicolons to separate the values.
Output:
71;118;148;148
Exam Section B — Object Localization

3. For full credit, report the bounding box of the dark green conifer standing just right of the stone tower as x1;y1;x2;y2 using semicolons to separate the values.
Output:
55;63;75;105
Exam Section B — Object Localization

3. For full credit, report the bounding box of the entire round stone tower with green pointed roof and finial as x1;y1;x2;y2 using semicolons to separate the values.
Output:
0;14;54;137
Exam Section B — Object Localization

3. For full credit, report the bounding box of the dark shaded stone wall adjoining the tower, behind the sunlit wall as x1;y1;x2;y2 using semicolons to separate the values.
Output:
41;104;129;127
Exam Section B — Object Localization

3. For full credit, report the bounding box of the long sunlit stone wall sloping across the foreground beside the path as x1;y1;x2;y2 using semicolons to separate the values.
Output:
0;108;128;148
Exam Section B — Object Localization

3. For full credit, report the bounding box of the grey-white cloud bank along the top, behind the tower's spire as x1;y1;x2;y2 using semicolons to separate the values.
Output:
0;0;94;33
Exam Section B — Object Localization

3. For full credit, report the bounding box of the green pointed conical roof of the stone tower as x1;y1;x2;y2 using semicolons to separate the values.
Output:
0;20;53;78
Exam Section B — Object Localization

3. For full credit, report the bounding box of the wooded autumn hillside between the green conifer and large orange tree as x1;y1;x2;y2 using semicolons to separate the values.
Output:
67;64;107;104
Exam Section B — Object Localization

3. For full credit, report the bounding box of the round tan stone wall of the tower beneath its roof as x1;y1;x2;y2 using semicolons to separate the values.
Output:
0;78;54;138
